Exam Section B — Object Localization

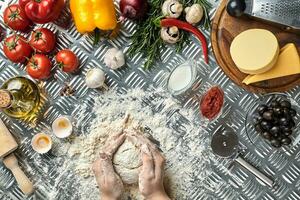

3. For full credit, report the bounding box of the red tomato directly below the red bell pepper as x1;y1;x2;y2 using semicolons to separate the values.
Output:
29;28;56;53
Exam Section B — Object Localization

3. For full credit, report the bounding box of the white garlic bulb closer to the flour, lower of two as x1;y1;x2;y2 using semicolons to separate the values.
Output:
85;68;105;88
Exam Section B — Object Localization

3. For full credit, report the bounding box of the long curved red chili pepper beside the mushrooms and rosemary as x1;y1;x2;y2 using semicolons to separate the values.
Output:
160;18;208;63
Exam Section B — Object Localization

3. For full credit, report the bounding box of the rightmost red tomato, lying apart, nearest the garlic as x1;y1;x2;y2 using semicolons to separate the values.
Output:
55;49;79;72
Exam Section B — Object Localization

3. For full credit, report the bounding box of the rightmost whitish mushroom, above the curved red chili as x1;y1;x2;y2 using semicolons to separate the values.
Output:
184;4;204;24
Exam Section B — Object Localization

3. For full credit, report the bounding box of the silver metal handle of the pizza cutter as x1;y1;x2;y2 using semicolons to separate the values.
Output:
235;156;274;188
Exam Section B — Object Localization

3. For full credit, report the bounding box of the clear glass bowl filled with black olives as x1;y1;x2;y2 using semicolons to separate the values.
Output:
246;93;300;148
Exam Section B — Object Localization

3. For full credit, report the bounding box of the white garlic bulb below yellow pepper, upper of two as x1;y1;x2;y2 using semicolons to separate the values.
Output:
104;48;125;69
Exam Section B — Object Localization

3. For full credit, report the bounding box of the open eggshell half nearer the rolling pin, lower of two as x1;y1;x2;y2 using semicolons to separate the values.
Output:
31;133;52;154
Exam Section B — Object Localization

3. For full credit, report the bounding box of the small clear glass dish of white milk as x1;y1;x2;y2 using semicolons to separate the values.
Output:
167;60;197;96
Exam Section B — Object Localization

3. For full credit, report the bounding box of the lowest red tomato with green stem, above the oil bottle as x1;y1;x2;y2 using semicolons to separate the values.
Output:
26;54;52;79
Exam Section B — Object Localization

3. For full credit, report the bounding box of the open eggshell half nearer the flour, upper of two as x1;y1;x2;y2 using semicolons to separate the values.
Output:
52;116;73;138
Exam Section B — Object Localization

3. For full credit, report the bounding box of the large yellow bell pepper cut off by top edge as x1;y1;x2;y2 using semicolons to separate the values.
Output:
70;0;117;33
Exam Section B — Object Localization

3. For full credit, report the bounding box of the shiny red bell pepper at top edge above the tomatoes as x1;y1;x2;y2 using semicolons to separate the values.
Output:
19;0;65;24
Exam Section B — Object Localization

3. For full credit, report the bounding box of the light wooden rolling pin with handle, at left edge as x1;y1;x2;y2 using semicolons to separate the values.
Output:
0;119;33;195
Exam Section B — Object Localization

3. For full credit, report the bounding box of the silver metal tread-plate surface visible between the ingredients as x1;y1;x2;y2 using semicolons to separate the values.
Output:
0;0;300;200
